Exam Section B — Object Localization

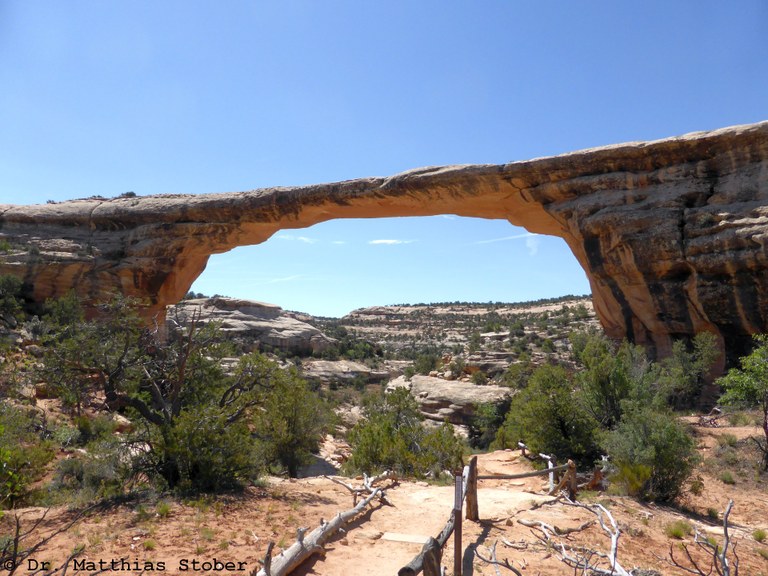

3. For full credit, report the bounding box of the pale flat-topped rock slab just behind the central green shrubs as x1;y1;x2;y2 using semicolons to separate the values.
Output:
387;375;512;426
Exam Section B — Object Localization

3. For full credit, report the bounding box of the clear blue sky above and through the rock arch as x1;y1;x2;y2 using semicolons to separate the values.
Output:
0;0;768;315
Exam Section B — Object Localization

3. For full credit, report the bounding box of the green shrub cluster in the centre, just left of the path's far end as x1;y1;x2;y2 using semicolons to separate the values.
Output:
348;388;463;477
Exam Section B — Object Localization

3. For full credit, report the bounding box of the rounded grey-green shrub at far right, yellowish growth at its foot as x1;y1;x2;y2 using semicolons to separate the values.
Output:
601;406;697;502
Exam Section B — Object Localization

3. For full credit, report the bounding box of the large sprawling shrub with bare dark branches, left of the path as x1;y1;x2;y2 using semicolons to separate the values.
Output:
39;296;328;491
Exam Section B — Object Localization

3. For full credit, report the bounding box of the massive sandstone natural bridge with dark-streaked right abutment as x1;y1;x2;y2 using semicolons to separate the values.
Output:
0;122;768;366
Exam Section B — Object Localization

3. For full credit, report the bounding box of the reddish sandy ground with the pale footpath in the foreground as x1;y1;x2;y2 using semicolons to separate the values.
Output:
0;428;768;576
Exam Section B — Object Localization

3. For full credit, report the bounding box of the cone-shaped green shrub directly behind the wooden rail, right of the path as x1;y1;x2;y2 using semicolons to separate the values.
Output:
494;365;599;467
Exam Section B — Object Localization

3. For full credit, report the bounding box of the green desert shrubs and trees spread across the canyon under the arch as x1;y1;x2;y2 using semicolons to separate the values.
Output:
0;277;768;572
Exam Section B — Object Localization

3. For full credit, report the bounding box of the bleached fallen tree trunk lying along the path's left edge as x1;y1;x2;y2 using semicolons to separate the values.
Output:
251;472;396;576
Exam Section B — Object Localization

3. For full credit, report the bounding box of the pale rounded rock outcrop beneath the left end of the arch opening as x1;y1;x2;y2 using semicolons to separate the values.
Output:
176;298;335;356
